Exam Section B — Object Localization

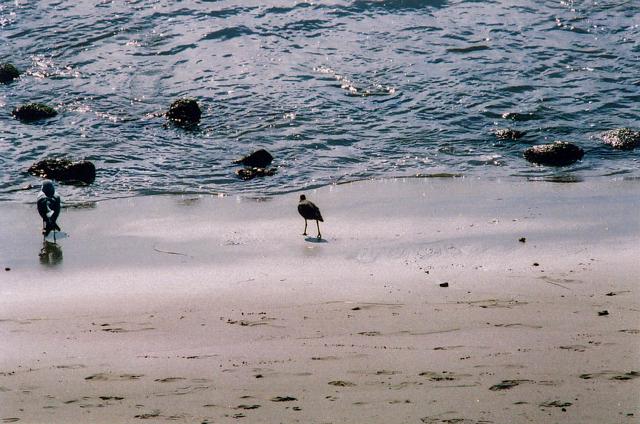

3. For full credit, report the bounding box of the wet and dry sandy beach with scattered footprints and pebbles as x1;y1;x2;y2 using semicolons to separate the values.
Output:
0;178;640;424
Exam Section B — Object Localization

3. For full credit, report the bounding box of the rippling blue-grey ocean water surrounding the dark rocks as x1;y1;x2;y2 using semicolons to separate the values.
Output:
0;0;640;201
